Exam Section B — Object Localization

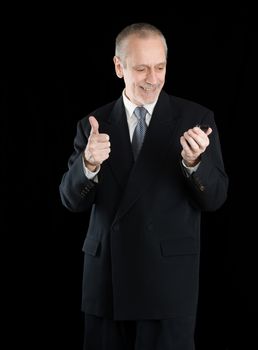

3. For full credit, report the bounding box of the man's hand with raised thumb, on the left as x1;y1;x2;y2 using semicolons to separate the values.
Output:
84;116;111;172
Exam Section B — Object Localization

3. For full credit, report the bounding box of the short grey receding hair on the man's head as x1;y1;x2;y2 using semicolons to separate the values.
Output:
115;23;168;64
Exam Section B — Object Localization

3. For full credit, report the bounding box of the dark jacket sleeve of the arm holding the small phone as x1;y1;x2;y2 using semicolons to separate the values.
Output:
181;111;228;211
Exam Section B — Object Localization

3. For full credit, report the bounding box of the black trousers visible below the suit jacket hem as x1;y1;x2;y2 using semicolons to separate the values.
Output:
83;314;195;350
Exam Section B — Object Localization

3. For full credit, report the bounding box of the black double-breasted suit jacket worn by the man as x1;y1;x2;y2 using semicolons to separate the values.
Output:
60;92;228;320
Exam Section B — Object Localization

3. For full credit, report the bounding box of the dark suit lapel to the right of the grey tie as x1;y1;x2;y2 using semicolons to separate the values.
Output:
116;92;177;219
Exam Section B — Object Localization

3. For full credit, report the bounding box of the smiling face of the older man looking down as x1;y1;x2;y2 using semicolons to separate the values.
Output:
114;35;166;105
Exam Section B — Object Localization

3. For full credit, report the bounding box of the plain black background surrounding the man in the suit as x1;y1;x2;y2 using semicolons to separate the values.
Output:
0;11;258;350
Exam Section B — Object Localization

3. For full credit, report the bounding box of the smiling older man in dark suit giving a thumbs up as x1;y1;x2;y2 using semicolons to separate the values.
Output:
60;23;228;350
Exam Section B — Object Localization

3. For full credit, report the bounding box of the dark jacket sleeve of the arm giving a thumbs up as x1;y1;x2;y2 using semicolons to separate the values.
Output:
59;119;97;212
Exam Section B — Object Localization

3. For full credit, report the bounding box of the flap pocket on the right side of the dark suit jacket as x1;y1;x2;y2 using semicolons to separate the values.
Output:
160;237;199;256
